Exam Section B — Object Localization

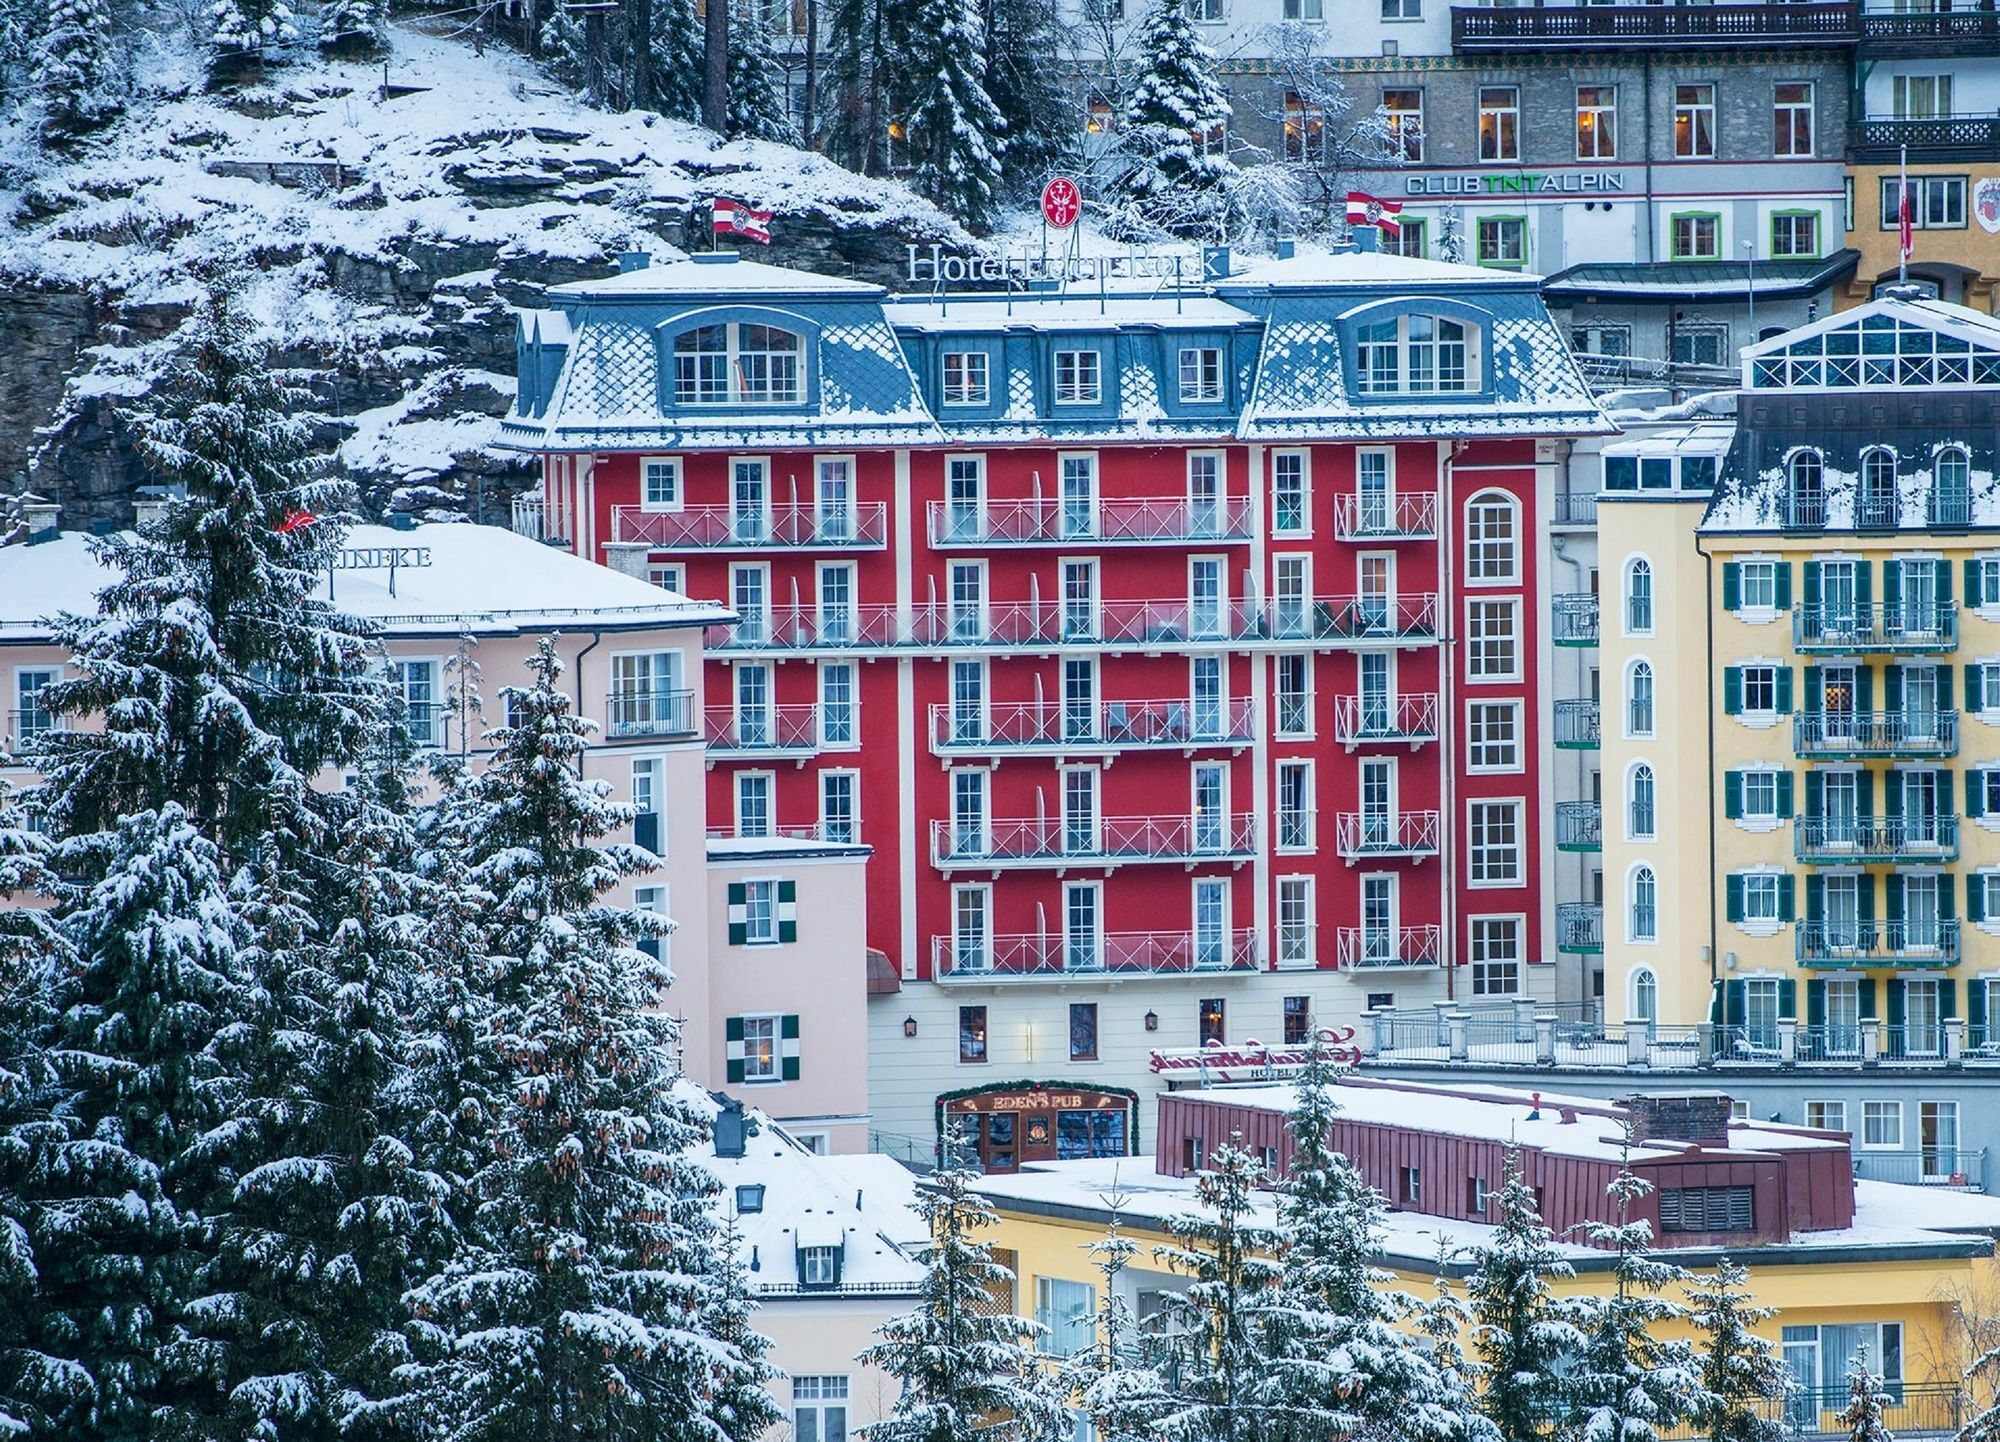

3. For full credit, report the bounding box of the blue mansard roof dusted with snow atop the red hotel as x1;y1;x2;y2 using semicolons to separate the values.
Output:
500;252;1610;450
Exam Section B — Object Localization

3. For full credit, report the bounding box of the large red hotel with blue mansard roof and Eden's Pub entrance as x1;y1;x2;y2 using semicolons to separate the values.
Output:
504;236;1606;1168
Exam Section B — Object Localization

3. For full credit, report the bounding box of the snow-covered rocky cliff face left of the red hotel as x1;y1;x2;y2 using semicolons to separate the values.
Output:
0;30;966;526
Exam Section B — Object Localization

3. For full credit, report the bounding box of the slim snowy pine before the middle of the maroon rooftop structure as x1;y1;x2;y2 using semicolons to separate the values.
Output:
1466;1148;1582;1442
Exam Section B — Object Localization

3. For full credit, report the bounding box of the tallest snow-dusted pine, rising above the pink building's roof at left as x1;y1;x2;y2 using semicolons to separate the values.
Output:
38;288;384;870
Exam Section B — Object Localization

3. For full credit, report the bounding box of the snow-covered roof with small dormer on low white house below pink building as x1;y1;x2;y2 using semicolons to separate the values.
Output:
700;1112;928;1304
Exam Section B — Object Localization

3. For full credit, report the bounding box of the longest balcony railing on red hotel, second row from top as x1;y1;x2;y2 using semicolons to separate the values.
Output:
708;594;1438;652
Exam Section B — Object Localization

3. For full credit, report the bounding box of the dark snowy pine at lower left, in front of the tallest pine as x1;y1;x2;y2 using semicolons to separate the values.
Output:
0;804;250;1442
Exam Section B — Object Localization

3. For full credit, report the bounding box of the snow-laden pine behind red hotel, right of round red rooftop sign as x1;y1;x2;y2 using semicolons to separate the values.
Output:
1118;0;1230;228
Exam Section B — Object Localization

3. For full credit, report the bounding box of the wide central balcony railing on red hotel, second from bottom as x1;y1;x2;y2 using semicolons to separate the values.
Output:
930;812;1256;868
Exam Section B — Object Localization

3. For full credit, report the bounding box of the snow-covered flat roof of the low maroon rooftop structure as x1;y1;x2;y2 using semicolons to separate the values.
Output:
1176;1076;1846;1162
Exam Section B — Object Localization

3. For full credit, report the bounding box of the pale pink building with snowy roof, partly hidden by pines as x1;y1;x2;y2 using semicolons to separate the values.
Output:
0;508;868;1152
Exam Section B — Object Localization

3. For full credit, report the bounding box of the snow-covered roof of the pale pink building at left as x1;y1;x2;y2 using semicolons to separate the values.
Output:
0;524;734;642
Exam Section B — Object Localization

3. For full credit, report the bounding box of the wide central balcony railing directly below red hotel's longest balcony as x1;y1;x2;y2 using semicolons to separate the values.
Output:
930;698;1256;756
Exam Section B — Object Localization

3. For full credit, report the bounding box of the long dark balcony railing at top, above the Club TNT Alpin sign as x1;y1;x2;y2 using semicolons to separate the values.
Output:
1452;0;1856;50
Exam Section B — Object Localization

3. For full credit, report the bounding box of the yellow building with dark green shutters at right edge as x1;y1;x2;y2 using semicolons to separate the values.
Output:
1600;298;2000;1080
